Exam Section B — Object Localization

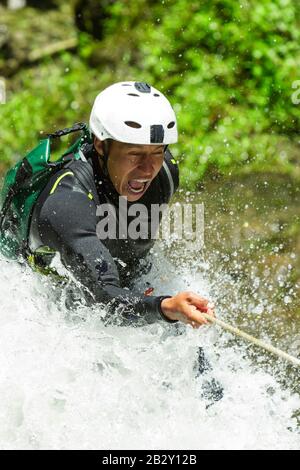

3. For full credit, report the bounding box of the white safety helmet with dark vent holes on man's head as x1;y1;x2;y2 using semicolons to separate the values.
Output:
90;82;178;145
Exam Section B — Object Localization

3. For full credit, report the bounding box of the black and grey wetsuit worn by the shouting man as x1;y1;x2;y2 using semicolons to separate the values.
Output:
29;145;178;323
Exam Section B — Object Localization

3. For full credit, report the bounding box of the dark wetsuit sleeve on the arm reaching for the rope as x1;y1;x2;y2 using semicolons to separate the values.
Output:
37;172;175;324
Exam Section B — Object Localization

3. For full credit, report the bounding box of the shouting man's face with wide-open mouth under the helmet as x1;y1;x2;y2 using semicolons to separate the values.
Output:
95;139;164;202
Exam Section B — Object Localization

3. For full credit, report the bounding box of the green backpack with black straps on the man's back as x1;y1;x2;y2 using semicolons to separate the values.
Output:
0;123;90;259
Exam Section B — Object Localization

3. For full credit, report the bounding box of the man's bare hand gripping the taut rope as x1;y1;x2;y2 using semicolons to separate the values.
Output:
161;292;215;328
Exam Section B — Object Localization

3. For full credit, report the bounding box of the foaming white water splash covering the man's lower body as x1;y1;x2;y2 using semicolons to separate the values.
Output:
0;256;300;449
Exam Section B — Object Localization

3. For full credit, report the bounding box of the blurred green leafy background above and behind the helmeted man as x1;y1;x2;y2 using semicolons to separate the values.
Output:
0;0;300;187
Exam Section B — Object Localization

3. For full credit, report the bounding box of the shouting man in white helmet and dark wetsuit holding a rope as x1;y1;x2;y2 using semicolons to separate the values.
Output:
29;82;214;328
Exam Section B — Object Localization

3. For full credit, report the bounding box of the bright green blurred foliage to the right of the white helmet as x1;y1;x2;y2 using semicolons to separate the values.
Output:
135;0;300;183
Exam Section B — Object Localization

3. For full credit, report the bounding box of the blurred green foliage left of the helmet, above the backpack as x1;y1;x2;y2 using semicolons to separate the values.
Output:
0;53;102;164
